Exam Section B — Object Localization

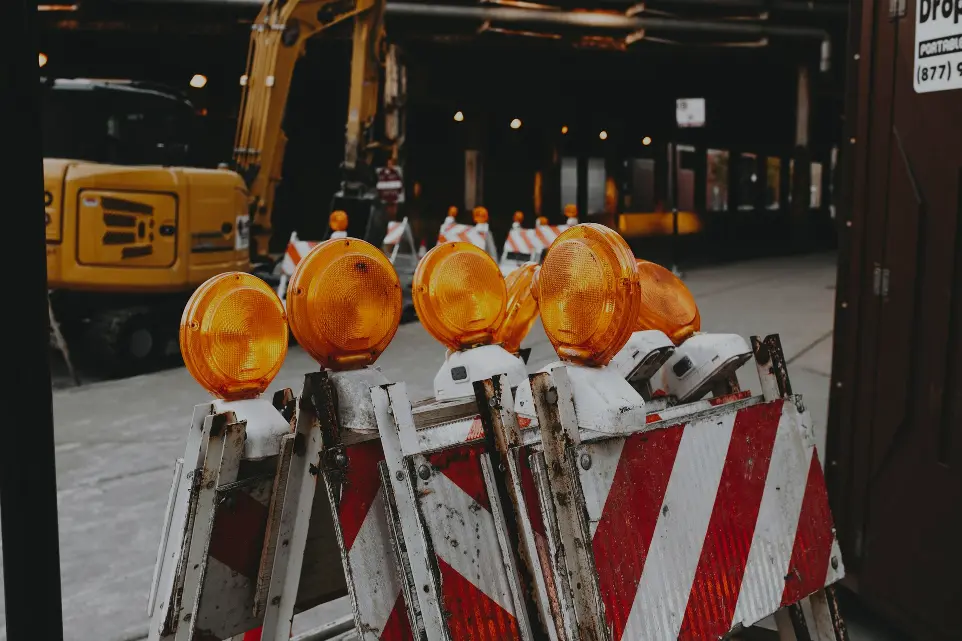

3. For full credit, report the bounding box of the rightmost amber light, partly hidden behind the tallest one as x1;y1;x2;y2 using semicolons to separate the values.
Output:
635;259;701;345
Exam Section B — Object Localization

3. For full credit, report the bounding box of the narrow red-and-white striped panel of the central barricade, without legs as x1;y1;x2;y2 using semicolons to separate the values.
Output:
416;444;520;641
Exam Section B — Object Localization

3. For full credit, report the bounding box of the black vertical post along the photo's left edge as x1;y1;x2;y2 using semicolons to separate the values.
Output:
0;0;63;641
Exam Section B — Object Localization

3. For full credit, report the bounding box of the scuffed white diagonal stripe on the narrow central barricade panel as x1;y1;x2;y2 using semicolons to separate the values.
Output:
422;470;514;616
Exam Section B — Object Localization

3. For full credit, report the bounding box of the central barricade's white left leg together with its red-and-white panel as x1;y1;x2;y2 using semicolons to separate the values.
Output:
372;383;539;641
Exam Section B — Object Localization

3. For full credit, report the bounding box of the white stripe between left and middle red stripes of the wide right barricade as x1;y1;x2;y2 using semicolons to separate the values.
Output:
622;412;735;641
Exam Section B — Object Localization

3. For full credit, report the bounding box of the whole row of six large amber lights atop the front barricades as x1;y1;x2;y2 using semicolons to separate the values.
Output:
180;223;701;400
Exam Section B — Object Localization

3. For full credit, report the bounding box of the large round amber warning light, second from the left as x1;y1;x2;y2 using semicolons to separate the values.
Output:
287;238;402;371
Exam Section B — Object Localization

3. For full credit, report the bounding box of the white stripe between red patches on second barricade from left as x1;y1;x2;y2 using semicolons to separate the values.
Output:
347;488;401;641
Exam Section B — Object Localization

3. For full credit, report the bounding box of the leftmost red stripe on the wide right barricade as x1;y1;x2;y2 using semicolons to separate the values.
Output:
592;425;684;641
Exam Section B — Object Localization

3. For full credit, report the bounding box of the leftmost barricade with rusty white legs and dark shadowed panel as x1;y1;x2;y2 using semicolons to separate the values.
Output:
147;389;346;641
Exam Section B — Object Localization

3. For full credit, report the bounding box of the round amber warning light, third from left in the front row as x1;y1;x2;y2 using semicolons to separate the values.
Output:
412;242;508;349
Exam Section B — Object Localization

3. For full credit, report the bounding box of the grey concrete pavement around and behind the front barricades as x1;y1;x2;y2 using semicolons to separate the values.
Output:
0;255;894;641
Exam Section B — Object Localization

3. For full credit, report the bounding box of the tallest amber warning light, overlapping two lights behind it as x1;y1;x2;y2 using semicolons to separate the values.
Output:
538;223;641;366
